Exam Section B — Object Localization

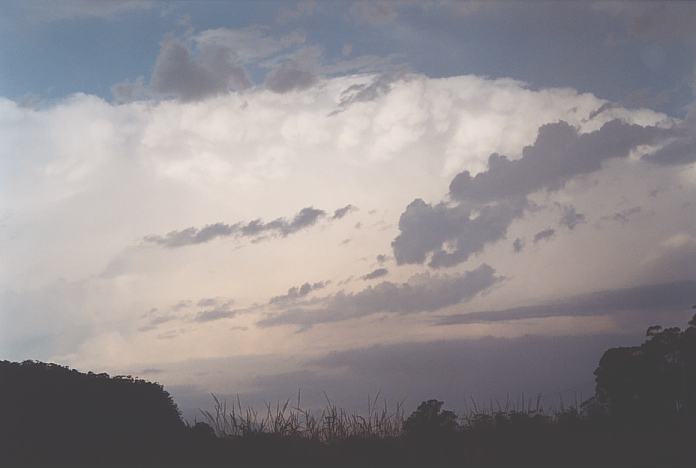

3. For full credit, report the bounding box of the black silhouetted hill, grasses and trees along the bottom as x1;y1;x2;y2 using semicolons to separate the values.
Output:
0;317;696;468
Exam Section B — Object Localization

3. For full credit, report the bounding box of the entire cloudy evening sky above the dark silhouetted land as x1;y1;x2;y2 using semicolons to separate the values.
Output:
0;0;696;418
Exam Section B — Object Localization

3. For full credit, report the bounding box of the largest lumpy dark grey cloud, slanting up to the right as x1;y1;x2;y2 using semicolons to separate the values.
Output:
392;120;670;268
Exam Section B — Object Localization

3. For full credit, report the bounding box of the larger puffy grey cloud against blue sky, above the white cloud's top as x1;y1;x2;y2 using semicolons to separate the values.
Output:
150;39;251;101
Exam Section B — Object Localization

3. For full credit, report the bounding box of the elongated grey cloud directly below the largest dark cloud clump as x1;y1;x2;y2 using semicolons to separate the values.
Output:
258;264;502;328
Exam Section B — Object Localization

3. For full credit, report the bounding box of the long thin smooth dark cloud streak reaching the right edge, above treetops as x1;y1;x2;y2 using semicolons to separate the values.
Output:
436;281;696;325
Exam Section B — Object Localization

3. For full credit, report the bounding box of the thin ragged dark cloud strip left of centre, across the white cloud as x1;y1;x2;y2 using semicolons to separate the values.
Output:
143;207;326;248
